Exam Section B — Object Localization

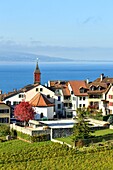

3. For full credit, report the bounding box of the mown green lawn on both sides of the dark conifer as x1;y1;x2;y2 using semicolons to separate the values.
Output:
56;129;113;145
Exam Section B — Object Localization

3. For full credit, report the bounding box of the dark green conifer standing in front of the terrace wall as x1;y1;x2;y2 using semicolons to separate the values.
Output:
73;108;92;141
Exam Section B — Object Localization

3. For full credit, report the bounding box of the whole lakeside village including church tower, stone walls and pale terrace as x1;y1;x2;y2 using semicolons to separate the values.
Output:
0;61;113;139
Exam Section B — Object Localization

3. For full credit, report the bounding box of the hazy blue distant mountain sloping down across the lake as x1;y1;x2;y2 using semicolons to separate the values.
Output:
0;52;73;63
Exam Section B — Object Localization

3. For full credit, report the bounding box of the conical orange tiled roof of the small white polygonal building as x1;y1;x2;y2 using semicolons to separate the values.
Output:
29;93;54;107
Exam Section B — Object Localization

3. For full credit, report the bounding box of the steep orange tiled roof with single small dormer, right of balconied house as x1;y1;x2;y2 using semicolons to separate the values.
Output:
69;80;88;96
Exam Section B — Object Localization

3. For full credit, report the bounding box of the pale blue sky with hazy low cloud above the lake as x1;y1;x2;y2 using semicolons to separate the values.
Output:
0;0;113;60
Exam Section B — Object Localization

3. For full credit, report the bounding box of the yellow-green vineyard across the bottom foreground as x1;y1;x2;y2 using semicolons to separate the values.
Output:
0;140;113;170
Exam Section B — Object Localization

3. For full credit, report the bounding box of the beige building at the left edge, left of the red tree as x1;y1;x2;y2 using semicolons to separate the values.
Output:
0;101;11;123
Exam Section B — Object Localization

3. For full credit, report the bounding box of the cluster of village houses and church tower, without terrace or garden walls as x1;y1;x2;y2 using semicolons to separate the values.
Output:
0;61;113;123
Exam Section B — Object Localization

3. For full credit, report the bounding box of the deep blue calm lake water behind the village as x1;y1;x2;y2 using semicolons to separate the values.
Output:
0;63;113;92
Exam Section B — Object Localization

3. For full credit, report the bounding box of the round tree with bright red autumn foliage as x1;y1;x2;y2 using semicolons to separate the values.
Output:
14;102;35;123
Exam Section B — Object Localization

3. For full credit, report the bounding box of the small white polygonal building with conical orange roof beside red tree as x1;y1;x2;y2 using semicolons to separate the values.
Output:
29;93;54;120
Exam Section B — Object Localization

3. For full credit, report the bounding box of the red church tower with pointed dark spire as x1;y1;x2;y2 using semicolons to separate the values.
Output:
34;59;41;84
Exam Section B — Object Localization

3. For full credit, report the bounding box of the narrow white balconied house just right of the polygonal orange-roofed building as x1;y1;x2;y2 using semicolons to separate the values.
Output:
48;80;72;118
